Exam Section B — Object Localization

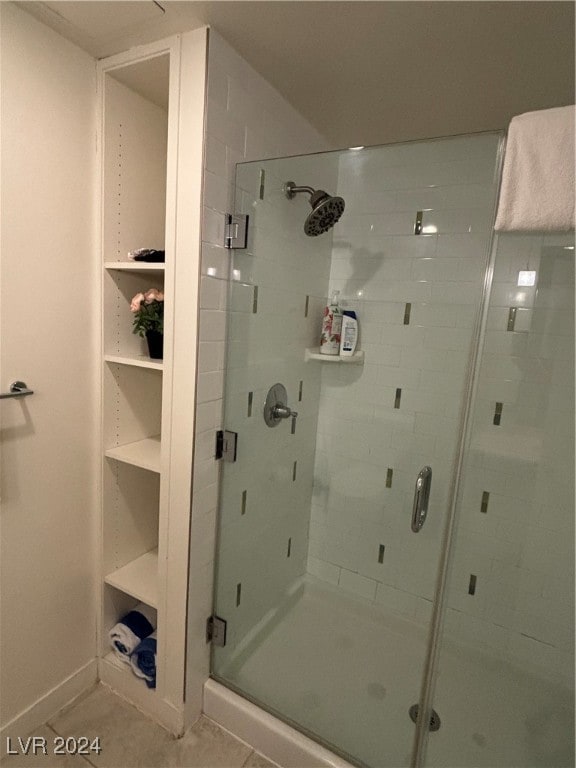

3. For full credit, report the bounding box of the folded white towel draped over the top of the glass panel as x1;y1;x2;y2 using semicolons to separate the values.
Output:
495;106;575;232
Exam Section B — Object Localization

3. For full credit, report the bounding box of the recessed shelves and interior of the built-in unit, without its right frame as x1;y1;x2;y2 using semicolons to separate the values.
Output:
102;48;166;703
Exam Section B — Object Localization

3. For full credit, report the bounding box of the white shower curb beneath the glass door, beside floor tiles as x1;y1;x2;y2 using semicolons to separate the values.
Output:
204;680;352;768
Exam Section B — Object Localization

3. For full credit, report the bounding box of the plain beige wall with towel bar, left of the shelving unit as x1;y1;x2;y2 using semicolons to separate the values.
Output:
0;3;98;736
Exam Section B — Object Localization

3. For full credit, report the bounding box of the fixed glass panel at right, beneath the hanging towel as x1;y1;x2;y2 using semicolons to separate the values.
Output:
427;235;574;768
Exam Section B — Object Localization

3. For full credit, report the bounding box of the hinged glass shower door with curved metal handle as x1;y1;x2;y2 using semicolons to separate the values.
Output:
213;134;500;768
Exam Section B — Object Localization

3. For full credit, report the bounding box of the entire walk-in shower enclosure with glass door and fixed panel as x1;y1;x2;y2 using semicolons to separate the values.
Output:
212;133;574;768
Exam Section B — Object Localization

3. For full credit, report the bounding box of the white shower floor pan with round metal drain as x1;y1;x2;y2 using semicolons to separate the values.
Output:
219;576;574;768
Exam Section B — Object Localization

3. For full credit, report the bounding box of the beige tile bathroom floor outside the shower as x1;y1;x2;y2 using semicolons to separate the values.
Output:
0;685;275;768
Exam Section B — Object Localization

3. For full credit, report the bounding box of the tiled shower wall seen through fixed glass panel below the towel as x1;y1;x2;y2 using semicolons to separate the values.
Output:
438;235;574;686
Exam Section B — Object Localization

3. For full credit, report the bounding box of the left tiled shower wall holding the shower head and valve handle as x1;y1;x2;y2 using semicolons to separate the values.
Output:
215;157;336;673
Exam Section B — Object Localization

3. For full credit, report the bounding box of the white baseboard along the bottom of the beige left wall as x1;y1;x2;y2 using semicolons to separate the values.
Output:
0;659;98;756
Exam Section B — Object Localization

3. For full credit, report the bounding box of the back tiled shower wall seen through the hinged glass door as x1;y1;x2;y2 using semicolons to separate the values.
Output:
308;134;499;620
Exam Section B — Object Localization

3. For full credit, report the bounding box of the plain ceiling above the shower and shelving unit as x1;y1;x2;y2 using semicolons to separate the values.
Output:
18;0;574;147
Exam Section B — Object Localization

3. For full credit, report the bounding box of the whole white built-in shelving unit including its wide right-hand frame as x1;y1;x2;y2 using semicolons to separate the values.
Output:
98;29;207;735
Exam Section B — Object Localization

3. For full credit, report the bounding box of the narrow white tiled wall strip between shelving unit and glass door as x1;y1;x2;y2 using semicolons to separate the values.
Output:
187;30;327;690
